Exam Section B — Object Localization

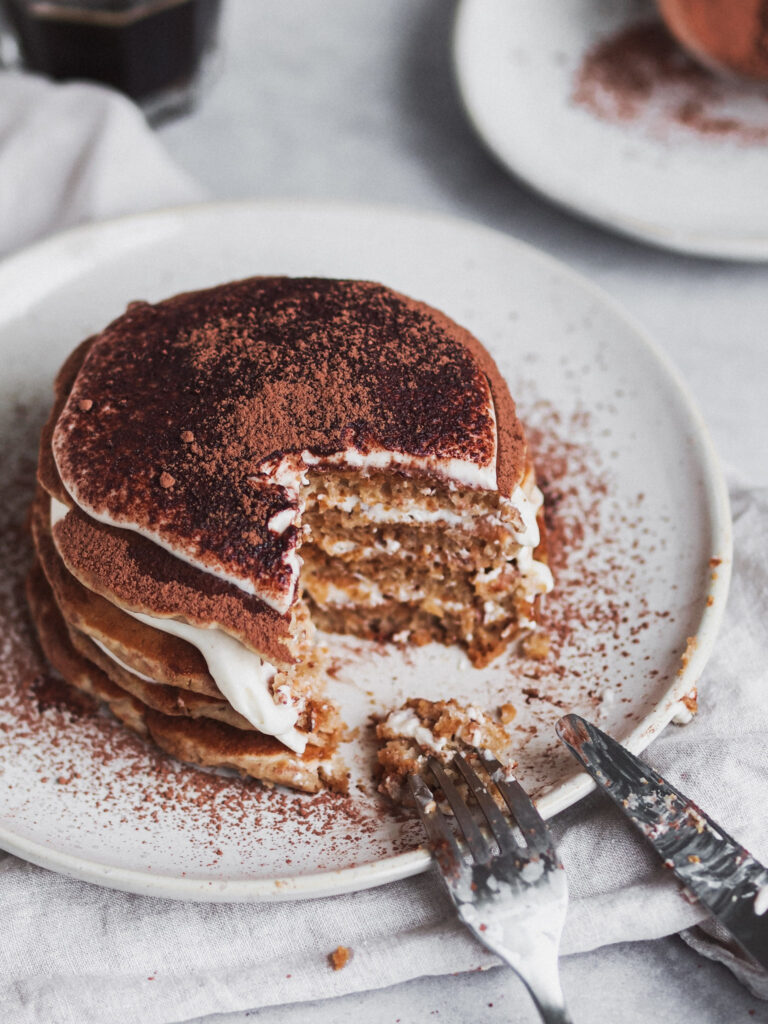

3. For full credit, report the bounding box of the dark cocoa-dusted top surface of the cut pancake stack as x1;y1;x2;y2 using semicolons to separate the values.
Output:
49;278;525;609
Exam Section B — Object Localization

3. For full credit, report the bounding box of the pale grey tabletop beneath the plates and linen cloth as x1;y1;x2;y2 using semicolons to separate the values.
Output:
159;0;768;1024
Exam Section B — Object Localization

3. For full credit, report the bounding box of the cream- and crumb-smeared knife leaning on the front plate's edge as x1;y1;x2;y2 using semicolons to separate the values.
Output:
557;715;768;968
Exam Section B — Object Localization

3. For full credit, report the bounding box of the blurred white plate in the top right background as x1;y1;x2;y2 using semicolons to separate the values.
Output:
454;0;768;260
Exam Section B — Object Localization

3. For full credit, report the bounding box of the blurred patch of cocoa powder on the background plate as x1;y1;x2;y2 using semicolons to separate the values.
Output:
571;22;768;145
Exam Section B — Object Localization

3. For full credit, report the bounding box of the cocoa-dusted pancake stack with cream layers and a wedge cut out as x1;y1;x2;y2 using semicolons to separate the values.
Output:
28;278;552;792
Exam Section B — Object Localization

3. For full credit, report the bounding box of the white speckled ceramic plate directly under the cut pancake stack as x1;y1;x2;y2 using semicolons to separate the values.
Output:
0;203;730;900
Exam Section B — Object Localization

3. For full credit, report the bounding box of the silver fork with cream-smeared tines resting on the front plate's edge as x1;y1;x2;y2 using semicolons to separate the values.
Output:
408;751;571;1024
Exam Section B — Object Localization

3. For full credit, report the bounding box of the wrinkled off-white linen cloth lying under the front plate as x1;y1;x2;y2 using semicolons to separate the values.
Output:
0;68;768;1024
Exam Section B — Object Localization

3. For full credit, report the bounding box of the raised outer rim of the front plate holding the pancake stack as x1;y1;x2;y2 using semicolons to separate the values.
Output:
0;199;732;902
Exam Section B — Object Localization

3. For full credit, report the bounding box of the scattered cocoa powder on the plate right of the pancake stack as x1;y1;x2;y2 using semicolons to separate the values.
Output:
489;382;684;770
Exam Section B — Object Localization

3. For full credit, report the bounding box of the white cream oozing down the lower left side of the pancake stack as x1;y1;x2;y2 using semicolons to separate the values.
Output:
50;498;307;754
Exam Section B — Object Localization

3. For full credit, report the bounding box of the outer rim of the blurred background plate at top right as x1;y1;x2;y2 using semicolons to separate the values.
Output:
451;0;768;263
